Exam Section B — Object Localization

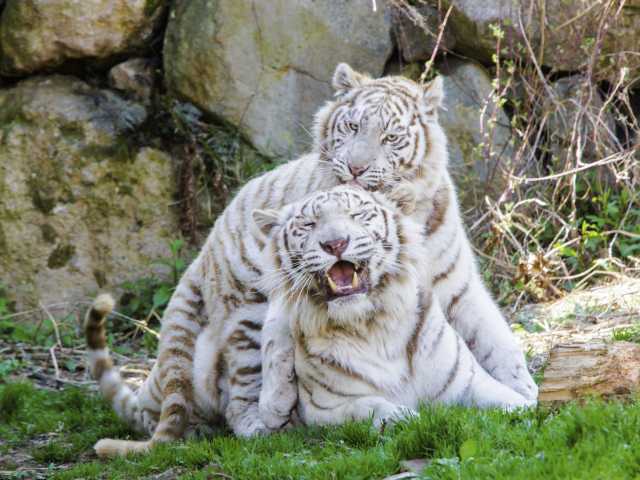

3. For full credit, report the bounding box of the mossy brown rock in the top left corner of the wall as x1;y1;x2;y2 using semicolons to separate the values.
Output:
0;0;166;75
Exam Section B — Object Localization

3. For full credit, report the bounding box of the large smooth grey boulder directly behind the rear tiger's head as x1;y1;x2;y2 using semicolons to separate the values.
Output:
164;0;392;157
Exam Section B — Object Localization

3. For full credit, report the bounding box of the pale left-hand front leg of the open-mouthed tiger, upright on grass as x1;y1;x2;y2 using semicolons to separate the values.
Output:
260;300;298;430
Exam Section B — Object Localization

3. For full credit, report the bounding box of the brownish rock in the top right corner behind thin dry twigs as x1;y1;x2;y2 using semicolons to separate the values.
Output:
429;0;640;79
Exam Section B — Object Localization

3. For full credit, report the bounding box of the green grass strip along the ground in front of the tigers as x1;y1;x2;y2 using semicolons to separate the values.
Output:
0;384;640;480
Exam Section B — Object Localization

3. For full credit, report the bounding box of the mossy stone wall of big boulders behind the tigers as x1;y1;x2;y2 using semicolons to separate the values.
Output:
0;0;640;308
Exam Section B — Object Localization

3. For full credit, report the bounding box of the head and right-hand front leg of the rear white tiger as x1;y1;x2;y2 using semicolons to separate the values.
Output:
315;64;538;400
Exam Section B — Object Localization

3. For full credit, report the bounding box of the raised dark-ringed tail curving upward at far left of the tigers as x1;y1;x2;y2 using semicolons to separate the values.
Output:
84;294;143;431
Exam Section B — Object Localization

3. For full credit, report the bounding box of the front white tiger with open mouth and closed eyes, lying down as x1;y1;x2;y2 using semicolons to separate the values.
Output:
254;186;532;428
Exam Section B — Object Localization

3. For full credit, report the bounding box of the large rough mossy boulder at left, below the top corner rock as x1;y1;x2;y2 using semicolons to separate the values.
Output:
0;76;178;308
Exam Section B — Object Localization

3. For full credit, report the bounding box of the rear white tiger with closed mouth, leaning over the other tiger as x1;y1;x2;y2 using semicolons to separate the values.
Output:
87;64;536;453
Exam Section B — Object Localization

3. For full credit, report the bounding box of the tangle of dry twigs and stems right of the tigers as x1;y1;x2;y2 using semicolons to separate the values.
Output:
392;0;640;309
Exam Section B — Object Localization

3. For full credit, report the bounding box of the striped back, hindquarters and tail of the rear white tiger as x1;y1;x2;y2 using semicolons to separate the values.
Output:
86;154;335;456
